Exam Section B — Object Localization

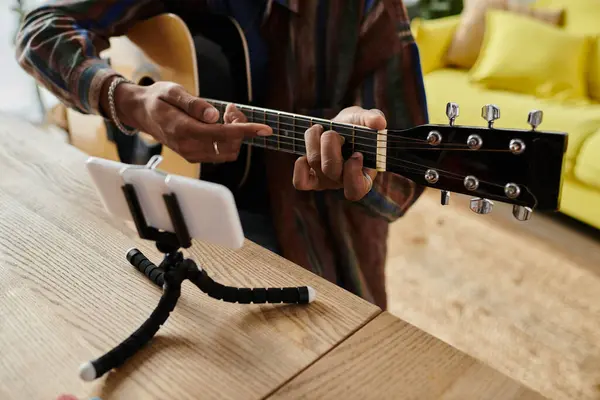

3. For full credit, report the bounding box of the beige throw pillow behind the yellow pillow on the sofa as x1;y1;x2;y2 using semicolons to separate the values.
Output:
446;0;563;69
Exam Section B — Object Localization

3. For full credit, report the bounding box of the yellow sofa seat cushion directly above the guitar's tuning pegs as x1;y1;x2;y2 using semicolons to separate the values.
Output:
425;69;600;172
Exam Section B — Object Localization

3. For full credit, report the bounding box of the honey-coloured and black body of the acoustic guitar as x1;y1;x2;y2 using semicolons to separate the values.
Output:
67;14;252;188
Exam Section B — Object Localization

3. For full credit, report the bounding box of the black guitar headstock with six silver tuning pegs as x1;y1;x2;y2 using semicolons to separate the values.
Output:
386;103;567;221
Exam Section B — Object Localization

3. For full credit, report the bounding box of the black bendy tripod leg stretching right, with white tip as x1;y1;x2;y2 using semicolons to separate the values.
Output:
184;259;317;304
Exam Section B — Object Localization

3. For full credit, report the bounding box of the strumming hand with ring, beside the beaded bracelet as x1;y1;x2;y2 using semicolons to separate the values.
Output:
101;81;273;163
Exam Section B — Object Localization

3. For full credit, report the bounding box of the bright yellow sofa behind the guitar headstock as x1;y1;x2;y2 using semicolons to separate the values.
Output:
411;0;600;228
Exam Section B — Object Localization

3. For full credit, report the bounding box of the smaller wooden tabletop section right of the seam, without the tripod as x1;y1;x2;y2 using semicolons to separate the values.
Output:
270;312;544;400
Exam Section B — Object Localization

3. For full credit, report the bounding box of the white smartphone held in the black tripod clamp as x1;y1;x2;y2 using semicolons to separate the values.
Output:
86;157;244;249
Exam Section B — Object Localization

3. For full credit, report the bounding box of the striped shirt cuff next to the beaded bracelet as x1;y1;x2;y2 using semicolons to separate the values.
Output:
71;59;121;119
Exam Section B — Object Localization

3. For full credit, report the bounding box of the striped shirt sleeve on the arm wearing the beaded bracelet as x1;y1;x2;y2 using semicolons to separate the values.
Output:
16;0;169;117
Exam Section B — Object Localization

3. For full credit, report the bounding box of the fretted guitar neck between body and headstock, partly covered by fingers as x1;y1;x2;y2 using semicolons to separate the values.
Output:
205;99;386;170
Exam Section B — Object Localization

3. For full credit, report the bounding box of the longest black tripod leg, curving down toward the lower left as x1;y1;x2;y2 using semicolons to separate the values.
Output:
79;271;185;381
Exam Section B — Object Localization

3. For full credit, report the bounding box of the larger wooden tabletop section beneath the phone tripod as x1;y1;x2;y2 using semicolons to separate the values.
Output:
0;116;380;400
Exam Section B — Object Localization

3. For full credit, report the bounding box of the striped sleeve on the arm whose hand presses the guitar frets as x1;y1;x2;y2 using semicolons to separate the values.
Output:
355;0;429;222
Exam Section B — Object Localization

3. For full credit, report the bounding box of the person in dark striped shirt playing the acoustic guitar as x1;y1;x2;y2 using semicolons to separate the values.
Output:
17;0;427;309
